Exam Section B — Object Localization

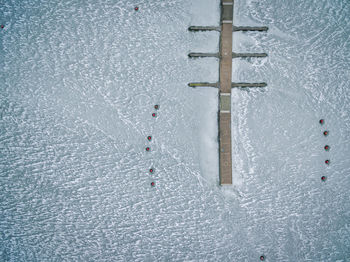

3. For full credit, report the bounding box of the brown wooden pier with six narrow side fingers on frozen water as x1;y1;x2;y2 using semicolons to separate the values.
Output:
188;0;268;185
